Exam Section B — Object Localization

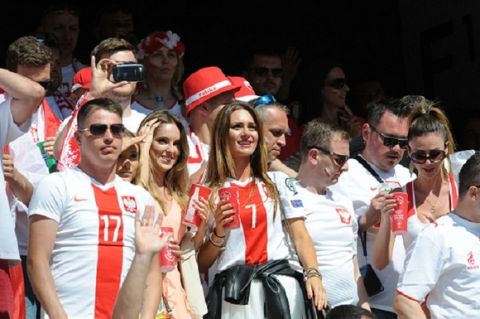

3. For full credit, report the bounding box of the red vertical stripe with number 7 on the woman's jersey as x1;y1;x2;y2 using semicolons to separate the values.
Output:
235;182;268;265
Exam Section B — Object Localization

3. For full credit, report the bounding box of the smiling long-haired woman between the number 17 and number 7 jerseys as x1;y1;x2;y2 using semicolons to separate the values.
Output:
135;110;203;319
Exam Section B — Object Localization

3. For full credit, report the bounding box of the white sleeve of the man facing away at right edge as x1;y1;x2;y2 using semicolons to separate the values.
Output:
397;225;447;302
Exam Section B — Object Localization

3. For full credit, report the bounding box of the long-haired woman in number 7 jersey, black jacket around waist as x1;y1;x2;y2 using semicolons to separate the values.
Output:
198;101;319;319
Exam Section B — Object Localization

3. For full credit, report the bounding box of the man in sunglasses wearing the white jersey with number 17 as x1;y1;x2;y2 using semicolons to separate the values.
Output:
28;98;158;318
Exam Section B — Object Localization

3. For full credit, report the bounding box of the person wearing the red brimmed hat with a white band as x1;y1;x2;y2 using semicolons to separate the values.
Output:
183;66;240;178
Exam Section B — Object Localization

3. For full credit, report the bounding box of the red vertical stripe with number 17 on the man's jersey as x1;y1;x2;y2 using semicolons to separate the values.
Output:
92;184;123;319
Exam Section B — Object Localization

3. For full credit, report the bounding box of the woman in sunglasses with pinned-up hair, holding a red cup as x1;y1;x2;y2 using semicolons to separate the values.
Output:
372;99;458;269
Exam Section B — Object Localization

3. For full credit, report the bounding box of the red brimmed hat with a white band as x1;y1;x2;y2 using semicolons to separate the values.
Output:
183;66;240;115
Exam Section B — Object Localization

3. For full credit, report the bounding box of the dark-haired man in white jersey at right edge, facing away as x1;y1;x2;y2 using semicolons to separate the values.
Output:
394;152;480;319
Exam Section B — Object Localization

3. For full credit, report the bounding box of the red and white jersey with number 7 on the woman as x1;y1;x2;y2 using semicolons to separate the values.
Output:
210;175;288;279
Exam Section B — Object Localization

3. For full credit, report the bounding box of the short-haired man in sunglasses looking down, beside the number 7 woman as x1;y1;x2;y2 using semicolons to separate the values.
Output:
277;120;370;310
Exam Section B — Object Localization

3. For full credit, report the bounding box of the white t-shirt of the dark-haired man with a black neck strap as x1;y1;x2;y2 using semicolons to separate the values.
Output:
329;158;412;312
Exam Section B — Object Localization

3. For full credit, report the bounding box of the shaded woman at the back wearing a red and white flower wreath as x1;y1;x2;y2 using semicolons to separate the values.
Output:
132;30;187;125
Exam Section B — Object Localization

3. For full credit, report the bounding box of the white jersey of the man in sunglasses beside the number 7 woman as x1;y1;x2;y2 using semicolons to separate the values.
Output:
276;178;359;307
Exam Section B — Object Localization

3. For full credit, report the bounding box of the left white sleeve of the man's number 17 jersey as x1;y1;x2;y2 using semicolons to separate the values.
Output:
28;173;68;223
